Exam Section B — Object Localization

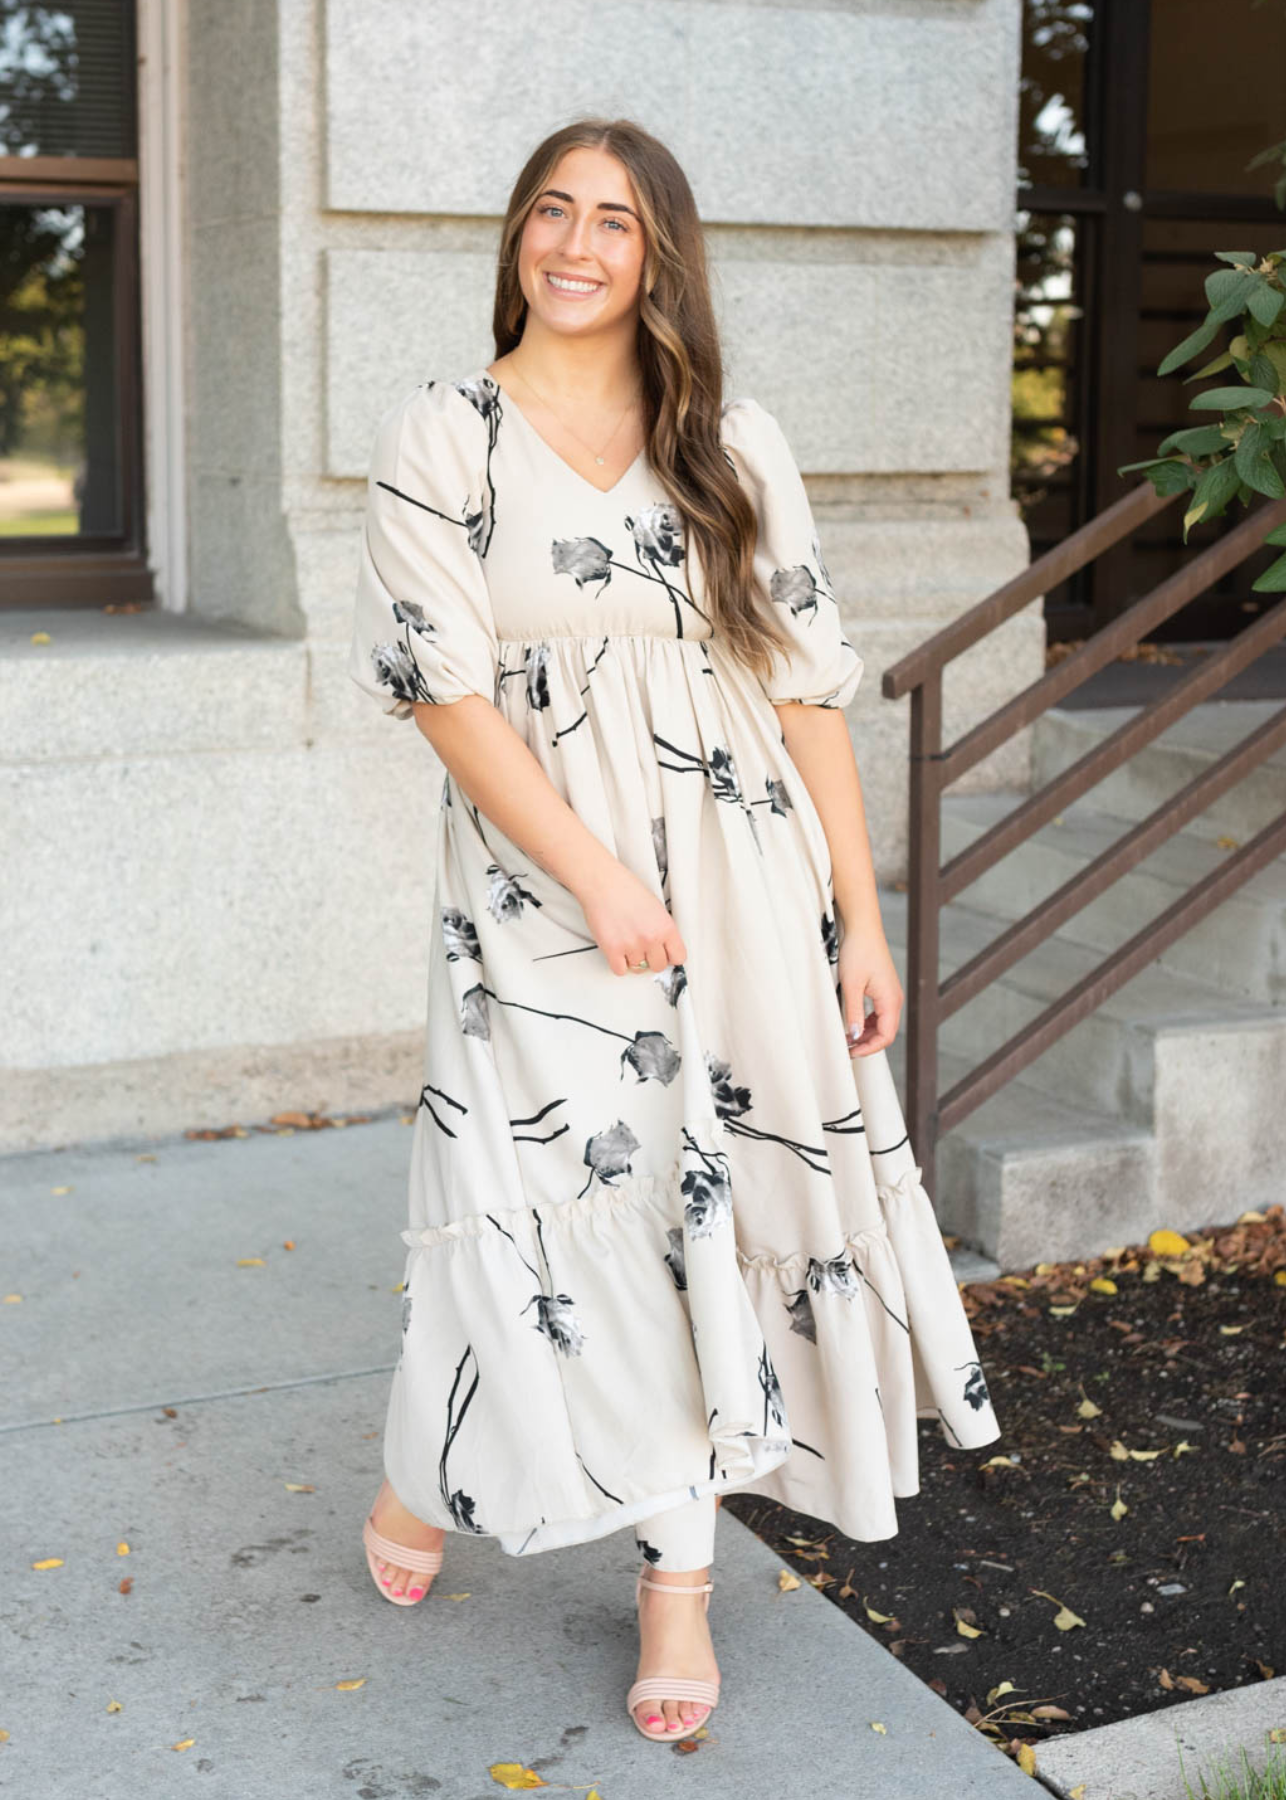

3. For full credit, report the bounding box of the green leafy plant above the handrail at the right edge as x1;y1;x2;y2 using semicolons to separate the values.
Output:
1117;250;1286;592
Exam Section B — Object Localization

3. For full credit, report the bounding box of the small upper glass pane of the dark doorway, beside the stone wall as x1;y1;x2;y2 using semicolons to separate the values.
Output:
1018;0;1095;187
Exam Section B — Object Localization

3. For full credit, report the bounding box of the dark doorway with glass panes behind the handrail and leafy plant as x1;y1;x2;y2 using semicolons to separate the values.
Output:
1012;0;1286;643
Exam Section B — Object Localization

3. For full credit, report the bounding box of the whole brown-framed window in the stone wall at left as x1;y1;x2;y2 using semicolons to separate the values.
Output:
0;0;153;607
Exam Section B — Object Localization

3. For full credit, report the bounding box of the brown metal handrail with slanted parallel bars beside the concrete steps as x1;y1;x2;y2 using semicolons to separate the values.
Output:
883;481;1286;1192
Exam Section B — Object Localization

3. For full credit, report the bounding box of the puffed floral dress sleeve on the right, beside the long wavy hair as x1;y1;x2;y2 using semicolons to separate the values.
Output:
722;400;863;707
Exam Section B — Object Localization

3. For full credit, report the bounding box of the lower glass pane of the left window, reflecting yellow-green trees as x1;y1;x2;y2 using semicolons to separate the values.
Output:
0;200;122;540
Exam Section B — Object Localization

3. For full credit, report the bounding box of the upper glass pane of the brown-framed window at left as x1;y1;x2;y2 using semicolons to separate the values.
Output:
0;0;139;157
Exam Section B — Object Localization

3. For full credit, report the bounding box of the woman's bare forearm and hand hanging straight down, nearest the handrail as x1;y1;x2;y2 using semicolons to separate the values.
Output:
774;700;902;1057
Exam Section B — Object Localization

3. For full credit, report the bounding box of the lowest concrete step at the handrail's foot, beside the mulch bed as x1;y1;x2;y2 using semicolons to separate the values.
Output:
888;1033;1159;1282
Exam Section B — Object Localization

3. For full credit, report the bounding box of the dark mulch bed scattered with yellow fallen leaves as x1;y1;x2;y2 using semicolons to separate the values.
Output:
724;1206;1286;1766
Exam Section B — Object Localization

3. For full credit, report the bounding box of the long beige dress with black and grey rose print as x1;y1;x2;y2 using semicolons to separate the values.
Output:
349;371;1000;1555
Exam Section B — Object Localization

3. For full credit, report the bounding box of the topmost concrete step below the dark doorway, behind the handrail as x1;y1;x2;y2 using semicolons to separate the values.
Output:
1032;700;1286;842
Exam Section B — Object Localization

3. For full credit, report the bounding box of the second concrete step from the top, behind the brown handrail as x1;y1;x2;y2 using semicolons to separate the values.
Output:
942;794;1286;1006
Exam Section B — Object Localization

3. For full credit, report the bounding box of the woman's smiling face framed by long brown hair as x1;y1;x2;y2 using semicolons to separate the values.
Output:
519;146;645;337
